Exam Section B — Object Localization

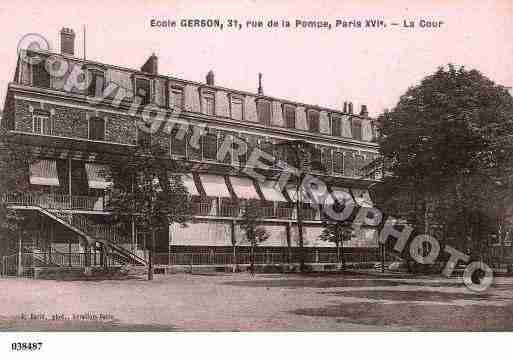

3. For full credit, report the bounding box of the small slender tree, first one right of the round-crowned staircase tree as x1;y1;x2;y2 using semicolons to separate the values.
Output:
240;201;269;273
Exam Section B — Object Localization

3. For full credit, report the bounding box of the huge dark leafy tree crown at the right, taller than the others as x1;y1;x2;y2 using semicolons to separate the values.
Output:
377;65;513;264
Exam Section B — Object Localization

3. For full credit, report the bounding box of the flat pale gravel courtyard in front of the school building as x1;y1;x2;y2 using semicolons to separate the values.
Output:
0;273;513;331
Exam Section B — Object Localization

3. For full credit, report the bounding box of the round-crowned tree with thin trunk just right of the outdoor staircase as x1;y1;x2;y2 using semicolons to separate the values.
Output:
108;139;193;280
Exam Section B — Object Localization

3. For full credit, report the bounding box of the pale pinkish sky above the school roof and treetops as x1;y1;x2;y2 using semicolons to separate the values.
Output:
0;0;513;116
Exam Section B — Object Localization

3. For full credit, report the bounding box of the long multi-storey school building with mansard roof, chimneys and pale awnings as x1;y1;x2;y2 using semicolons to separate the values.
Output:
2;29;378;272
